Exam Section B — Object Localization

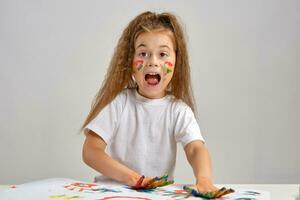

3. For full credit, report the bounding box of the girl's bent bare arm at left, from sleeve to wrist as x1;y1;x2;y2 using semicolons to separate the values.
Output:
82;130;141;186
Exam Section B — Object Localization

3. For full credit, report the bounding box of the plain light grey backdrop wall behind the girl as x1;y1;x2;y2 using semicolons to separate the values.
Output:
0;0;300;184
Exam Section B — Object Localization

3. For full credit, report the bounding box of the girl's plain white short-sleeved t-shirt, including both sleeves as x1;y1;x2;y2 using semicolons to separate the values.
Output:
85;89;204;179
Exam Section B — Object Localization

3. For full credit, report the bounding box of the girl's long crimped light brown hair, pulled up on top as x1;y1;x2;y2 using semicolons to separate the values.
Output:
81;11;195;130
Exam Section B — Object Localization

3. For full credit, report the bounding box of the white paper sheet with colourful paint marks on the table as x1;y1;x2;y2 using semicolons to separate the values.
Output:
0;178;270;200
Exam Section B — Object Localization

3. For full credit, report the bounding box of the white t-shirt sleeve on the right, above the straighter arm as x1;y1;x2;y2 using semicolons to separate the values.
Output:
174;105;204;147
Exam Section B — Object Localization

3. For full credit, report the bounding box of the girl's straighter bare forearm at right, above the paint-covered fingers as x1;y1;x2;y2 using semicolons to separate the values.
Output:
184;140;218;193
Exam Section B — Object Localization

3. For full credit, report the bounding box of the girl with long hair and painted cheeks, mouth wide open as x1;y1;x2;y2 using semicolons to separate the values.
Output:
82;12;217;193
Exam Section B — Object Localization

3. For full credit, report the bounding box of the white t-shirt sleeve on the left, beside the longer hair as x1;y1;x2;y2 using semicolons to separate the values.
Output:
84;92;123;144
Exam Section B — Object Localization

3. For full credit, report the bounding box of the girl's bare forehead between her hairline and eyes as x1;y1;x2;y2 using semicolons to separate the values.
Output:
134;30;174;50
